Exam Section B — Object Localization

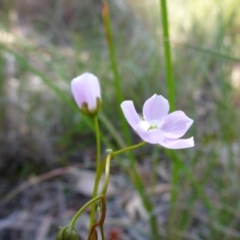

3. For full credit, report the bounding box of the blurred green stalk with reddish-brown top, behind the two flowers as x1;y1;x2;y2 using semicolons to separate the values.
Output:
102;1;160;239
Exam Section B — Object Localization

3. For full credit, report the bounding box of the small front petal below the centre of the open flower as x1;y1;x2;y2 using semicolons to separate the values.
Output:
136;121;163;144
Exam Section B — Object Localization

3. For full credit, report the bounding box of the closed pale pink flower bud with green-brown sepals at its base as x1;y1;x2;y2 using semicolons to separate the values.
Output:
71;73;102;117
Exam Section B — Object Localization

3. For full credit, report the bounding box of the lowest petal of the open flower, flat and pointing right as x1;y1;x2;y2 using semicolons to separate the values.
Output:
159;137;194;149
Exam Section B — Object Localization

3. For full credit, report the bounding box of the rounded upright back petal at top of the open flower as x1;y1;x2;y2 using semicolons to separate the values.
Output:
143;94;169;122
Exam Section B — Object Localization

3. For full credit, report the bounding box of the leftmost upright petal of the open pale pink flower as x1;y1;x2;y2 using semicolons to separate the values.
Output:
120;100;142;131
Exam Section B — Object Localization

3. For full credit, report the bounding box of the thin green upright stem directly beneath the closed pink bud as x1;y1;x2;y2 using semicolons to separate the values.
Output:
90;116;101;228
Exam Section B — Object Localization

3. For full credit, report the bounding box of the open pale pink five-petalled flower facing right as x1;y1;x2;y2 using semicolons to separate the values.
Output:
121;94;194;149
